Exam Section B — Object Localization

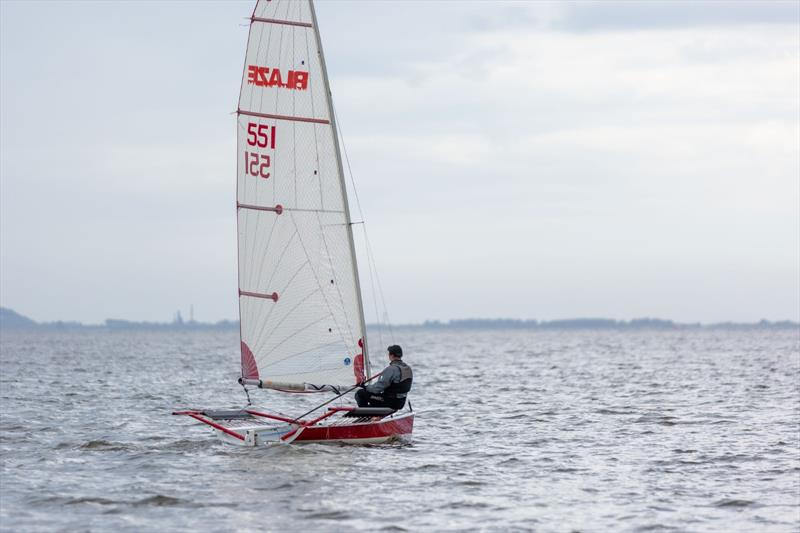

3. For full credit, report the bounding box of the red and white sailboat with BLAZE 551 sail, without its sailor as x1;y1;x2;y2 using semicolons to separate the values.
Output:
174;0;414;446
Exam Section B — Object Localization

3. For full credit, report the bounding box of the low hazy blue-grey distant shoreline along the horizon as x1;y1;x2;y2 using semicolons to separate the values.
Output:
0;307;800;331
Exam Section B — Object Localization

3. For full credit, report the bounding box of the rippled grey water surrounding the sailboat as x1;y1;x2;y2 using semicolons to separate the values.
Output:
0;330;800;531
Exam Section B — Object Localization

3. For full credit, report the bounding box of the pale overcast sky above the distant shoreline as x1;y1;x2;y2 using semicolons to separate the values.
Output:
0;0;800;323
